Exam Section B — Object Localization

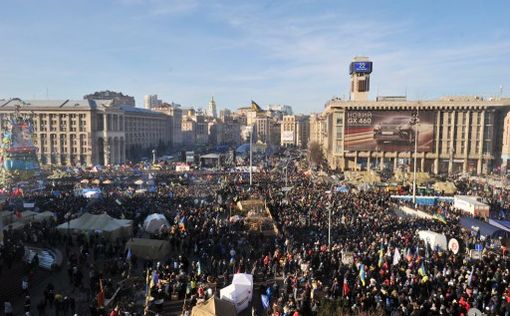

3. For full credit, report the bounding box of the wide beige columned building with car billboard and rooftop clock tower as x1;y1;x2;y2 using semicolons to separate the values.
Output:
322;57;510;174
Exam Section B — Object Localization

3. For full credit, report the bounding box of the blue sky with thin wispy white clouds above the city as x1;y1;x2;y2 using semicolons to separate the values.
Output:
0;0;510;113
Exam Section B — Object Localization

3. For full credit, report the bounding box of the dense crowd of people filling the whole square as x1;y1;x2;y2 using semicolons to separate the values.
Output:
0;152;510;316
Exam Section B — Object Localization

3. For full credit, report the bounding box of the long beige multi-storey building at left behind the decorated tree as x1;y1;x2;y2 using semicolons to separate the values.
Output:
0;97;172;166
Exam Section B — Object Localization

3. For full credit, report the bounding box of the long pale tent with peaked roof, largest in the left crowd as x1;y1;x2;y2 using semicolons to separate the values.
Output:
57;213;133;239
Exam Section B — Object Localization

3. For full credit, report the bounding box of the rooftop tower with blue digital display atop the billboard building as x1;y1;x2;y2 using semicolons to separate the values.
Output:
349;57;372;101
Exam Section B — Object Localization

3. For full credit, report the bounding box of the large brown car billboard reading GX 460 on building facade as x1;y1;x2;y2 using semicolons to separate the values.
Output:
345;111;435;152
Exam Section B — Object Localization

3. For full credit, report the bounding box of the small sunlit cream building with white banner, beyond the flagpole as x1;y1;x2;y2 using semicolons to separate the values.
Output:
281;115;310;148
